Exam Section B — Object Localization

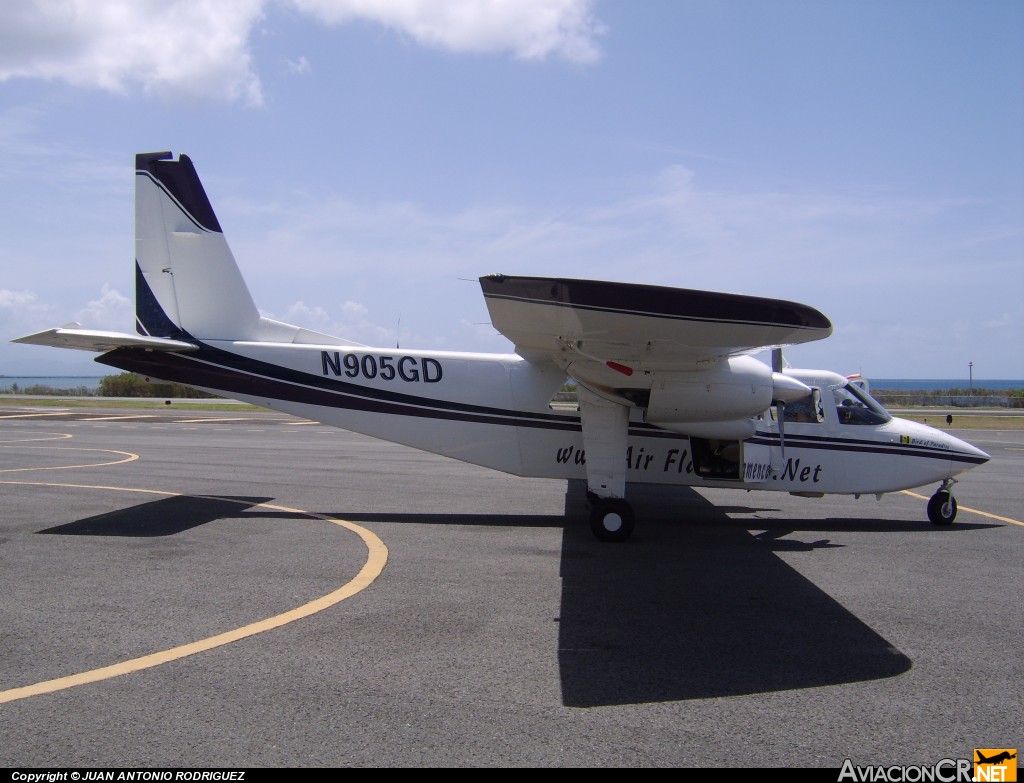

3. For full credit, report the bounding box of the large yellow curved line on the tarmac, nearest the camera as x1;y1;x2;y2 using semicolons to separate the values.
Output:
0;481;388;704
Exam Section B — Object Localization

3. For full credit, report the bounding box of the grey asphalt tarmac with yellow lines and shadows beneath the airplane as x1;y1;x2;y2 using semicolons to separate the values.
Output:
0;403;1024;770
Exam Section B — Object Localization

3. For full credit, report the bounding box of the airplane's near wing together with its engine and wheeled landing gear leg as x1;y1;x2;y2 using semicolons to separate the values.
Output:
480;274;831;539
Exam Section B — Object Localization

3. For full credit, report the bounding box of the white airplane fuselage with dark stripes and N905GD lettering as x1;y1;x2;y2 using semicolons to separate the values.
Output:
104;341;987;494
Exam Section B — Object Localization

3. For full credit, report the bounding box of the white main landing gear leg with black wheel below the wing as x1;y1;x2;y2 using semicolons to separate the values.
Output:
578;384;634;541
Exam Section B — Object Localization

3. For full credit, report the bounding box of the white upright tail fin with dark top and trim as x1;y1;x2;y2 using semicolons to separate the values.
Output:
135;153;260;340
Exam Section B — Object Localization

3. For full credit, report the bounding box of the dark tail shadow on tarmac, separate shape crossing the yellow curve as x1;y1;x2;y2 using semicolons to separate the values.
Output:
38;495;273;538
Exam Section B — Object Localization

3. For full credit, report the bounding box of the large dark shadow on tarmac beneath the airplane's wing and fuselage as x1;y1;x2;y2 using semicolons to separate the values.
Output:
331;482;1003;707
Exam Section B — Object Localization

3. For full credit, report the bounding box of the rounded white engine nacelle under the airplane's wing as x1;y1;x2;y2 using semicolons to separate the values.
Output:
645;356;770;423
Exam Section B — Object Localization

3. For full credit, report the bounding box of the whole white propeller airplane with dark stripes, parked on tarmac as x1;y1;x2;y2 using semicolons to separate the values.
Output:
14;153;989;541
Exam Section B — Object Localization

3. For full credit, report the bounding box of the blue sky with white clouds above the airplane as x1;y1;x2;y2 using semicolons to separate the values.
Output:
0;0;1024;379
